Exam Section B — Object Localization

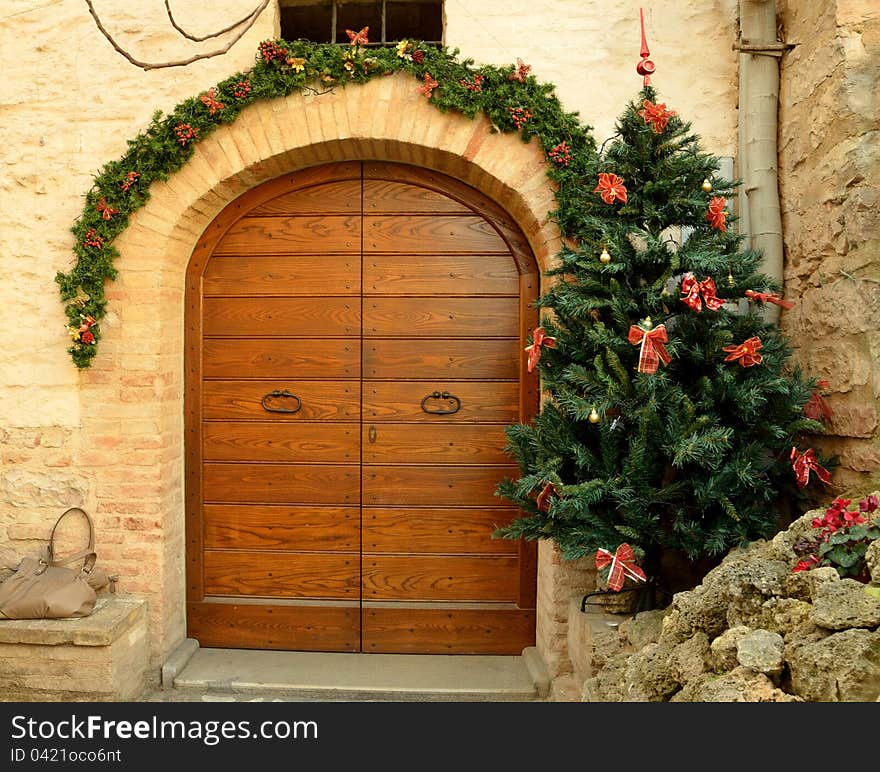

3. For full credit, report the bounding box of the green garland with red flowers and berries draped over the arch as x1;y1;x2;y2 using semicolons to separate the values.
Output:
55;40;598;368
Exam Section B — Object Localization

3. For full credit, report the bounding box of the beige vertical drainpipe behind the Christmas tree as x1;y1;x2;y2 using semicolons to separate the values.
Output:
735;0;791;322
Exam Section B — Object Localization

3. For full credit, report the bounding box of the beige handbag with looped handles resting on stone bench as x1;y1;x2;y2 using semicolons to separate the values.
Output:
0;507;116;619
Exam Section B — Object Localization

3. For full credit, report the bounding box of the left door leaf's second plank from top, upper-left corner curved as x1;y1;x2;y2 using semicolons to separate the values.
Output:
214;215;361;255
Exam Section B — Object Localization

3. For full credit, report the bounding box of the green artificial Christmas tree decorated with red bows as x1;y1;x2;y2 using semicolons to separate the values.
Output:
498;79;827;592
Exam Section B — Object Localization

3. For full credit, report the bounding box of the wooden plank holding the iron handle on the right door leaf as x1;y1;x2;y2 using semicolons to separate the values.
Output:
363;379;519;424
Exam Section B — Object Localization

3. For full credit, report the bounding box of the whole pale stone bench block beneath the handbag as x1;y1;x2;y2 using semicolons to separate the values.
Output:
0;598;150;702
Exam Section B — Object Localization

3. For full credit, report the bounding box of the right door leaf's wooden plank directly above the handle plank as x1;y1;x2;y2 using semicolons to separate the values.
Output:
363;339;519;380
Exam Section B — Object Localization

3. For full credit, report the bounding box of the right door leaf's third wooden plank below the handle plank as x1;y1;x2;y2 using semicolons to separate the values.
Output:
363;507;519;555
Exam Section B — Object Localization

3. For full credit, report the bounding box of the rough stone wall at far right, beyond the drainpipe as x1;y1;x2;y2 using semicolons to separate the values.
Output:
778;0;880;495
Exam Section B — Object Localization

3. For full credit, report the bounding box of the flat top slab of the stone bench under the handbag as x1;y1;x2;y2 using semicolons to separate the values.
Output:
0;598;146;646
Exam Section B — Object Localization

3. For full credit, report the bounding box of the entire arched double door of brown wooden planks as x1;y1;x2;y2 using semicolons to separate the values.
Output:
186;162;538;654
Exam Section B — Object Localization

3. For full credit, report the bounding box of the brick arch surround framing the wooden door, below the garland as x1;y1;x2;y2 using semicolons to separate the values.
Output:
81;73;592;669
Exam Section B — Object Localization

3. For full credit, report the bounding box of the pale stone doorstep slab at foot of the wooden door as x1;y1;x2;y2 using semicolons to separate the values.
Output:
174;649;542;702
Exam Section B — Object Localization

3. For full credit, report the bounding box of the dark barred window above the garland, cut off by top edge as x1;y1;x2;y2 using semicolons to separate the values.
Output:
279;0;443;46
